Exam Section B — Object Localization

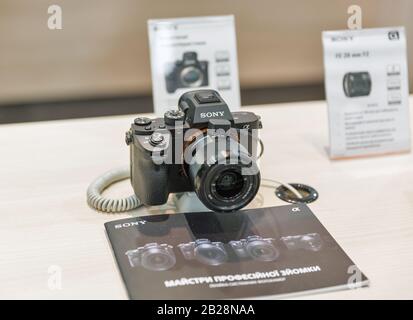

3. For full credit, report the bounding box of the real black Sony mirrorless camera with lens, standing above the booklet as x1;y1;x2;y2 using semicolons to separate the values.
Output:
126;90;262;212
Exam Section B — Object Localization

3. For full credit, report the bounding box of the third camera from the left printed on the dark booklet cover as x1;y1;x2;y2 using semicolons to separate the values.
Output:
229;235;280;261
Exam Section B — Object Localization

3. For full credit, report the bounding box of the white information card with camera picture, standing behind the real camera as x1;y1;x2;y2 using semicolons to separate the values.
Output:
148;16;241;115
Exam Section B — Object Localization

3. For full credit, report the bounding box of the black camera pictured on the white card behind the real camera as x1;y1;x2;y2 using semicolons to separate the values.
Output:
165;51;209;93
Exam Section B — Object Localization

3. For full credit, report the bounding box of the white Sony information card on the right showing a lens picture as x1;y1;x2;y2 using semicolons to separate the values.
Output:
322;27;410;159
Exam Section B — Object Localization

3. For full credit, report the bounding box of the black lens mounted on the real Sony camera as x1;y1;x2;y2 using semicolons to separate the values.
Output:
188;137;260;212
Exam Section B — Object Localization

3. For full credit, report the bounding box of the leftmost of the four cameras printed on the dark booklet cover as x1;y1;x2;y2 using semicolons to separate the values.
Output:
125;243;176;271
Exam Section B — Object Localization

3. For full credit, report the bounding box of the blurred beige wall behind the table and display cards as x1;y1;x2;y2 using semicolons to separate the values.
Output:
0;0;413;119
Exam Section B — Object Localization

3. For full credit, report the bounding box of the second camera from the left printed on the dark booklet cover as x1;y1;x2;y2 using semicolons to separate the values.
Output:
178;239;228;266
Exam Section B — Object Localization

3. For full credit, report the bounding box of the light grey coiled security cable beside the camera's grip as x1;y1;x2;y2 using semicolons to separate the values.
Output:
87;166;142;213
